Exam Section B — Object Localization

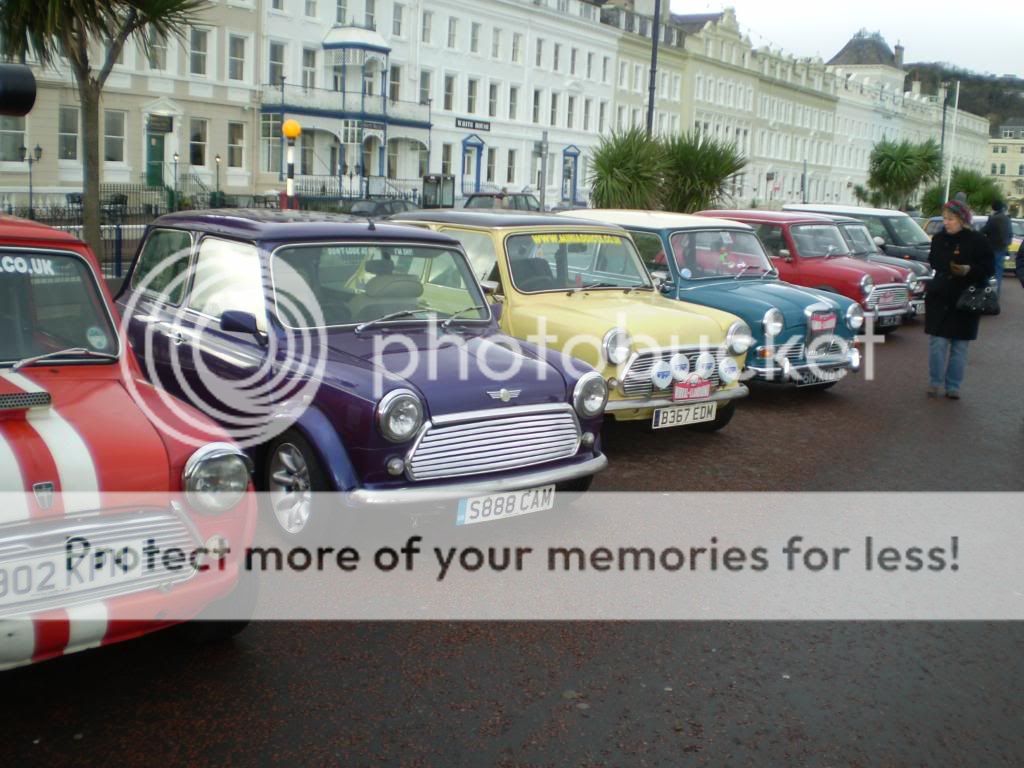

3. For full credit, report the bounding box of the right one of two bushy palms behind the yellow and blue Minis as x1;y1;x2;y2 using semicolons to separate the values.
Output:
662;132;746;213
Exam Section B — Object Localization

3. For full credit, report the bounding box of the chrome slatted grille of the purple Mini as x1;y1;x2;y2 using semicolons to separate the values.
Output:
408;407;580;480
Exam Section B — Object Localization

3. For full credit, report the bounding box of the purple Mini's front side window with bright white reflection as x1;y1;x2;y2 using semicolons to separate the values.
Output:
188;238;266;331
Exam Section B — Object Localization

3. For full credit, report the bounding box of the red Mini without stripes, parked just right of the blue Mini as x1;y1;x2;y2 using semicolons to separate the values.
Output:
697;210;911;331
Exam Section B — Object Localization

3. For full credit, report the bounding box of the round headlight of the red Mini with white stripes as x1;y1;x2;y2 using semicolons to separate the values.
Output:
181;442;253;515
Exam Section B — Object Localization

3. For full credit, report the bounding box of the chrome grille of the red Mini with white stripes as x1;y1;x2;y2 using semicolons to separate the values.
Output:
0;510;199;618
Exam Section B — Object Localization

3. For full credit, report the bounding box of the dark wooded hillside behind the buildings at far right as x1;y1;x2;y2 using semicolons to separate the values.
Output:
905;62;1024;136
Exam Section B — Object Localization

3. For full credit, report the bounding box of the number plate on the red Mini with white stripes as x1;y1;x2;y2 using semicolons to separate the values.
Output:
0;540;153;608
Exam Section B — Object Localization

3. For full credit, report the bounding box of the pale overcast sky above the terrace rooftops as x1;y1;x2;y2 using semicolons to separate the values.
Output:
671;0;1024;77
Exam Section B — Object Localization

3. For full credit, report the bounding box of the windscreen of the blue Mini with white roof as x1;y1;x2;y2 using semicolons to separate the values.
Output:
669;229;774;280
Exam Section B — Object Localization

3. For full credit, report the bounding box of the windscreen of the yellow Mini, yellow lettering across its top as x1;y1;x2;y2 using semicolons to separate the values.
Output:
505;231;651;293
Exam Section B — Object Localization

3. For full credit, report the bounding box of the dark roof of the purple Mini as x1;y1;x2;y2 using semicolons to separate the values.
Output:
150;208;454;245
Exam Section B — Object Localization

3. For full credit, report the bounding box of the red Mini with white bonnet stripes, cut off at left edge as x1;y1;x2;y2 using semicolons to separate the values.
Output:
0;216;256;669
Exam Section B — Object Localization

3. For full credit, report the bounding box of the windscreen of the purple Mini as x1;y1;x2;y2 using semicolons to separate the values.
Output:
270;244;490;328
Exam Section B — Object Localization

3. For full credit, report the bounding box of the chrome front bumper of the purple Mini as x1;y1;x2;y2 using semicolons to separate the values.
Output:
345;454;608;507
